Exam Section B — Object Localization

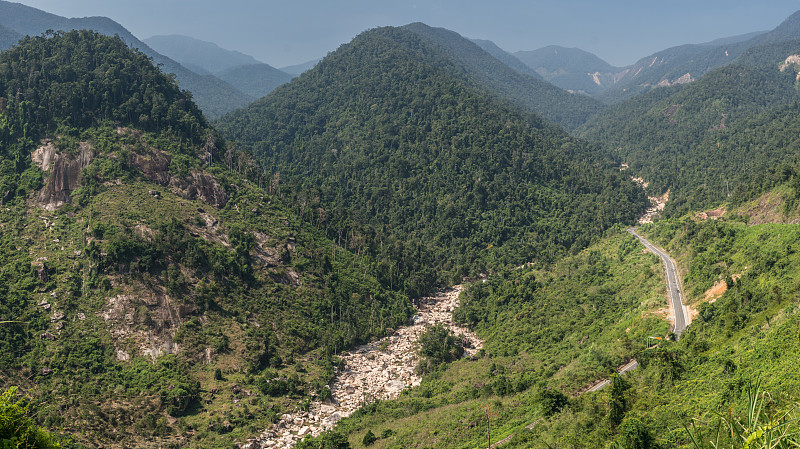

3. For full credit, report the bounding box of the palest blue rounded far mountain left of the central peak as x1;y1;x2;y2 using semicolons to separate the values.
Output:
143;34;261;74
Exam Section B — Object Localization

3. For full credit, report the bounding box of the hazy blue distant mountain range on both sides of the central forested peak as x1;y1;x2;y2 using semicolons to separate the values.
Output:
0;0;800;126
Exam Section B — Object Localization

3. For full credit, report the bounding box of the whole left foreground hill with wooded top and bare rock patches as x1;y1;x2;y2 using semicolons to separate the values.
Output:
0;31;412;447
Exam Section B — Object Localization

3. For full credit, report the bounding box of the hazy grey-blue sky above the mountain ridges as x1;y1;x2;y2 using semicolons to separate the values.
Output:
10;0;800;67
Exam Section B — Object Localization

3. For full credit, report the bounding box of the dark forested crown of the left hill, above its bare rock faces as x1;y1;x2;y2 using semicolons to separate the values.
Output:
0;31;207;144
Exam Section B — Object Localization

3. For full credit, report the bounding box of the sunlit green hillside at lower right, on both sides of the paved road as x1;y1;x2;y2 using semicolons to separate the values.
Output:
305;203;800;449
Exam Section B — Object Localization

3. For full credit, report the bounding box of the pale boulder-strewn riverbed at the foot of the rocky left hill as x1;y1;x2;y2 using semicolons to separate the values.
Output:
242;285;483;449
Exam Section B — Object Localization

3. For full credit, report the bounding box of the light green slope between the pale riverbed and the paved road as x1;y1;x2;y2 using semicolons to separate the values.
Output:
296;230;668;448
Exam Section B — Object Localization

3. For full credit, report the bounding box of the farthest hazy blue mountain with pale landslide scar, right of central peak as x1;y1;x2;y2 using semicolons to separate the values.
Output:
514;45;624;95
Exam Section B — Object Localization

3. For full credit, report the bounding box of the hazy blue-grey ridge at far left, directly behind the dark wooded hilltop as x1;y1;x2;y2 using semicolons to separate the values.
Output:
0;0;255;117
